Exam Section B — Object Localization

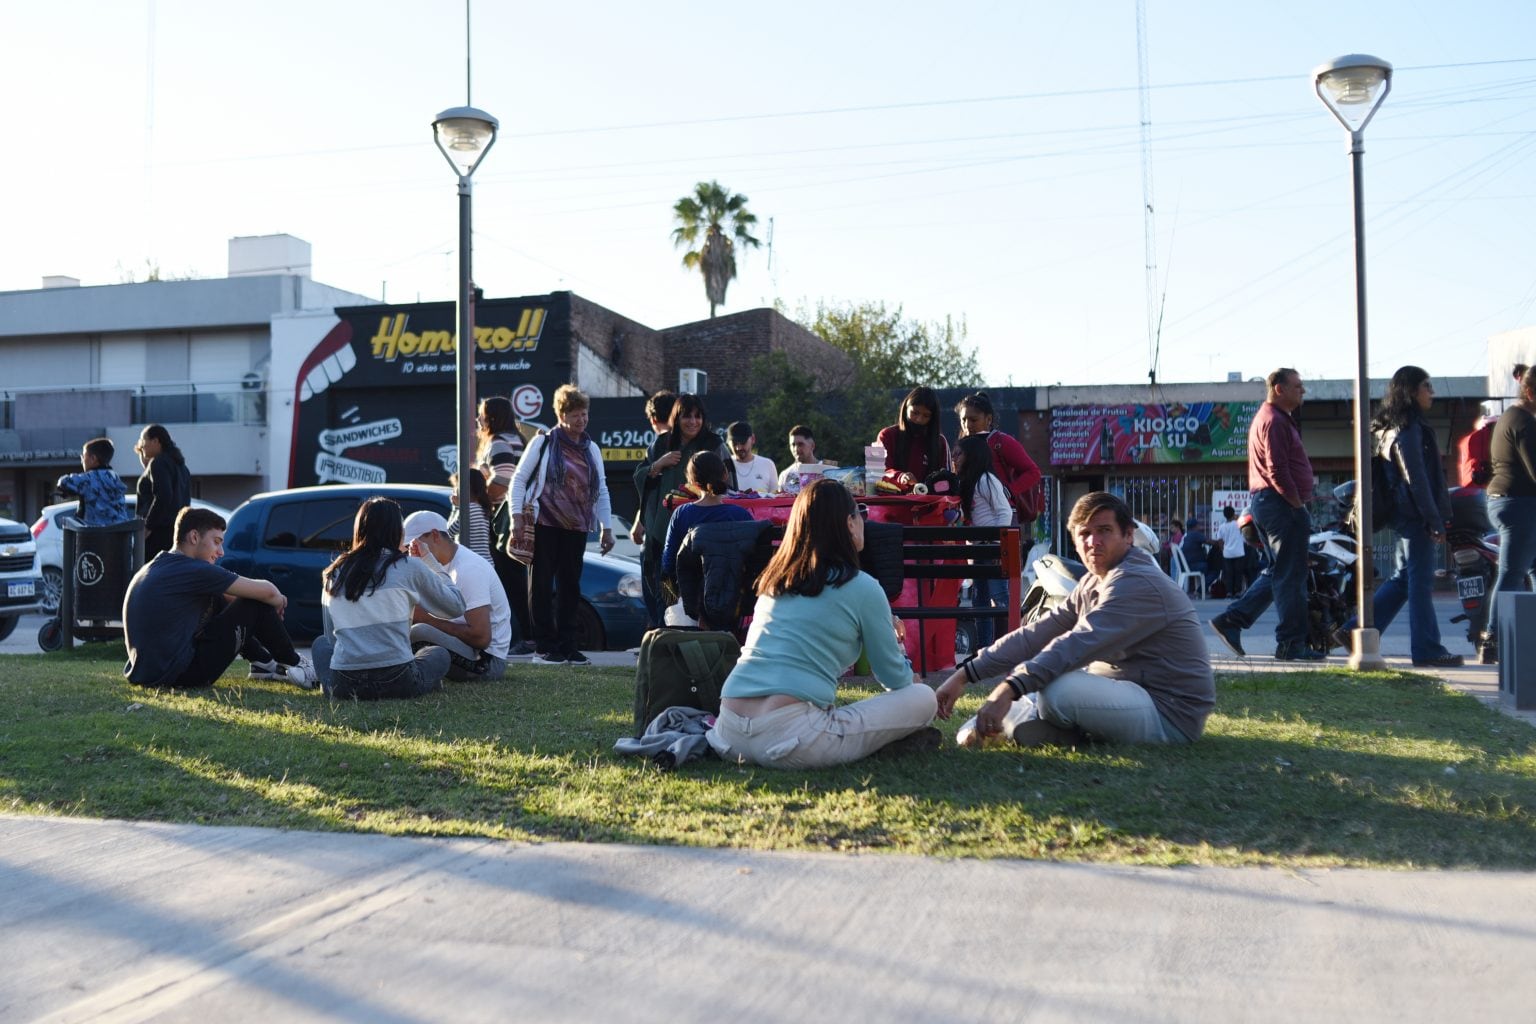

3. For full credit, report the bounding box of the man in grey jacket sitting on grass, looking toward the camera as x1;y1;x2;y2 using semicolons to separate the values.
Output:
937;491;1217;746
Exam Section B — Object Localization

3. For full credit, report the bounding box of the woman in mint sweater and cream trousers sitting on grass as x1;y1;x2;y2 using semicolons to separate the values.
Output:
708;481;938;768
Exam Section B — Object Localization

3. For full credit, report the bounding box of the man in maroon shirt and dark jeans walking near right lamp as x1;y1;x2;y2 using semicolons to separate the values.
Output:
1210;367;1327;662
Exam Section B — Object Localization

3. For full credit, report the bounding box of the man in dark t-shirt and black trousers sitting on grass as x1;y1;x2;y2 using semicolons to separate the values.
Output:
123;507;315;689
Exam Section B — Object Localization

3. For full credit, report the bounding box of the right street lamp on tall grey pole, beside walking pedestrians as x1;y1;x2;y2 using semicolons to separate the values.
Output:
1312;54;1392;669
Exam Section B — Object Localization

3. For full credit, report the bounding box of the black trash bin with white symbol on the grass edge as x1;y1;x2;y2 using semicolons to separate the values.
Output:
58;516;144;646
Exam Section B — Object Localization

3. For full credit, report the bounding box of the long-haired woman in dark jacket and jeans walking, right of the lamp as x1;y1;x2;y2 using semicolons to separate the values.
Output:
1346;365;1462;668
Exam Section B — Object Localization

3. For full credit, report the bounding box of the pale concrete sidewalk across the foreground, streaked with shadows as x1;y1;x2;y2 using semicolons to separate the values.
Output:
0;817;1536;1024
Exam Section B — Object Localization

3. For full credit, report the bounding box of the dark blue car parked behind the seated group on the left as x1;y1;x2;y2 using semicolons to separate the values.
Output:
220;484;645;651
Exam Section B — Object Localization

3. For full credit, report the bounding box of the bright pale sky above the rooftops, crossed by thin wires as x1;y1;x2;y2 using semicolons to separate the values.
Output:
0;0;1536;385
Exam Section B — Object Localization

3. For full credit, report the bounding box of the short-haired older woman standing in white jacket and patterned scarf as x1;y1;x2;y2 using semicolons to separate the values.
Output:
507;384;613;665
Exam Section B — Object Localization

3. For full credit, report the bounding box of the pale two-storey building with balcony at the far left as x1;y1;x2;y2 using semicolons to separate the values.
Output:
0;235;375;519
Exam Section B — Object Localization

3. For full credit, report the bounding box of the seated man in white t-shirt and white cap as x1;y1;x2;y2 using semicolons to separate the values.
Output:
406;511;511;682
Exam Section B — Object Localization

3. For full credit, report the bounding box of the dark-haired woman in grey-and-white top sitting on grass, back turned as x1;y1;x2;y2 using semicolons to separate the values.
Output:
313;497;464;700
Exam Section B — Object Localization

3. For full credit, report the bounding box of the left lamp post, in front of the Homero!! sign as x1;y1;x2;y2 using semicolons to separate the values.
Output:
432;106;499;525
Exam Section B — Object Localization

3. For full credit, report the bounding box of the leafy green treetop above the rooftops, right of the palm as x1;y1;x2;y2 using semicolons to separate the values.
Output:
799;302;982;388
